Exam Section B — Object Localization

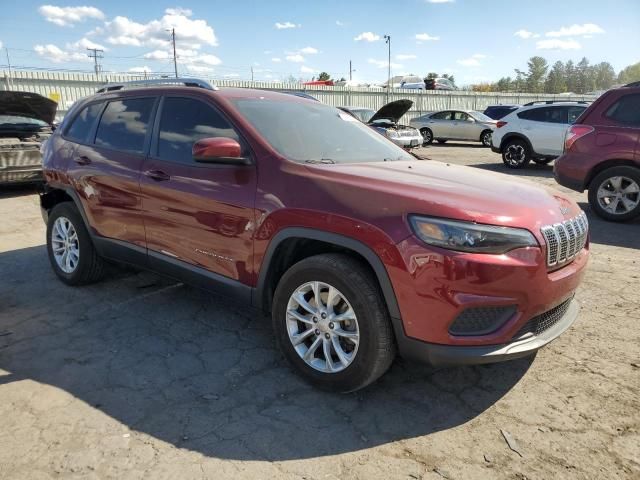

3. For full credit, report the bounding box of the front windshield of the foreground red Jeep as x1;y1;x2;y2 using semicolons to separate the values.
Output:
233;98;413;163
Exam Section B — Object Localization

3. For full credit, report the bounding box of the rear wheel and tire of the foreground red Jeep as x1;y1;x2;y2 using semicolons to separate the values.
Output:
47;202;105;285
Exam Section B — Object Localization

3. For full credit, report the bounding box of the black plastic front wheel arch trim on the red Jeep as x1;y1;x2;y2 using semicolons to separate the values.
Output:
252;227;400;322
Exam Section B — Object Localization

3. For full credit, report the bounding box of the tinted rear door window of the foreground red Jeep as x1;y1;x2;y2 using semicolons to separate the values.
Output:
95;97;156;153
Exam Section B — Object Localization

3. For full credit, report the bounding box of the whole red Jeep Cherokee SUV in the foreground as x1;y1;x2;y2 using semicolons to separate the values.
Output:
41;80;589;392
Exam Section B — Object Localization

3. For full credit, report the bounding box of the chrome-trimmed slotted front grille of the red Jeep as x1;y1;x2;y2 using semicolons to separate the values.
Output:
540;212;589;267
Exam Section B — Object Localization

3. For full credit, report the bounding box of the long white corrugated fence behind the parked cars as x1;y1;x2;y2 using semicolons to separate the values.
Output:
0;70;594;121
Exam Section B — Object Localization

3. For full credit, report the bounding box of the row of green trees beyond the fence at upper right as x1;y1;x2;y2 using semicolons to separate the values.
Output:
471;56;640;94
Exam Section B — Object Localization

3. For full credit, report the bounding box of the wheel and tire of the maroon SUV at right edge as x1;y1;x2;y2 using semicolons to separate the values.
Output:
589;166;640;222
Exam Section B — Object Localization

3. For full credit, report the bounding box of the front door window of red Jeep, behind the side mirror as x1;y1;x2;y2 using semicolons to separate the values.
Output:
157;97;240;163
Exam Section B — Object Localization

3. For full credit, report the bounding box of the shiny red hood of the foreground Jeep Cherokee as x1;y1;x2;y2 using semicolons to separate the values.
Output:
314;161;581;237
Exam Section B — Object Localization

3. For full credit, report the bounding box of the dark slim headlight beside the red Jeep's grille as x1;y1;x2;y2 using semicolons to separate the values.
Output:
409;215;539;254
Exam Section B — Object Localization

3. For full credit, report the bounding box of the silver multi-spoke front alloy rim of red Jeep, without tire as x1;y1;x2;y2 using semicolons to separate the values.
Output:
286;282;360;373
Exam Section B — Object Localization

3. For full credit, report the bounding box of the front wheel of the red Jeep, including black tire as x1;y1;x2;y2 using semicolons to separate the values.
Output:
272;253;396;393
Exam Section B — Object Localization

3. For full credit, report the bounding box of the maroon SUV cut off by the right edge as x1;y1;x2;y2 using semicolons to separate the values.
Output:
554;82;640;221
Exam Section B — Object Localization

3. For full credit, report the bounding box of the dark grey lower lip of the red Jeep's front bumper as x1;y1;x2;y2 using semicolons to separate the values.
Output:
398;300;580;366
